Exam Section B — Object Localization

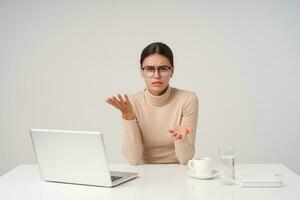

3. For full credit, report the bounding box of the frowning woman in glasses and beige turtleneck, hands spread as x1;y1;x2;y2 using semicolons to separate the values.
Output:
106;42;198;165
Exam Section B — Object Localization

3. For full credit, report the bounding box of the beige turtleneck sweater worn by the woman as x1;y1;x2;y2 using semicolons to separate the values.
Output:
122;87;198;165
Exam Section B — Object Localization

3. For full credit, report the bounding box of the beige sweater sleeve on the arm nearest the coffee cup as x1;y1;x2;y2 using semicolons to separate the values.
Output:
174;93;198;164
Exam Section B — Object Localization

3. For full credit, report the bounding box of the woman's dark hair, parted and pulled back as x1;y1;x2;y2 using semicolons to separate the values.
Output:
140;42;174;66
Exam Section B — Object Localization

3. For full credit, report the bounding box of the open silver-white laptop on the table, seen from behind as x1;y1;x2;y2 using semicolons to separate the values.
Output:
30;129;138;187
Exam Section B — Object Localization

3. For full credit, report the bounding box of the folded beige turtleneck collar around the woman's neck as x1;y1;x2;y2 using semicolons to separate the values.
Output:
145;86;173;106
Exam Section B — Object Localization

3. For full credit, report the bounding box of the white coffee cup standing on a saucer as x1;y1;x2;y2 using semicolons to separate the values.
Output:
188;157;212;176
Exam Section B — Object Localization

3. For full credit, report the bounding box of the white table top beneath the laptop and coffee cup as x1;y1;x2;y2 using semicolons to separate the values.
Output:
0;164;300;200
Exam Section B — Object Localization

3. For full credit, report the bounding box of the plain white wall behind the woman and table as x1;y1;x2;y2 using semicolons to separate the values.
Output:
0;0;300;175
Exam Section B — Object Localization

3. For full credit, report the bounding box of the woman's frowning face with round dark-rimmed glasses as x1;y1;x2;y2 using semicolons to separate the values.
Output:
141;54;173;96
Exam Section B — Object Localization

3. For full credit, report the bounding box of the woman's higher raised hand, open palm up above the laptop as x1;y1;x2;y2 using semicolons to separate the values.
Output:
106;94;135;120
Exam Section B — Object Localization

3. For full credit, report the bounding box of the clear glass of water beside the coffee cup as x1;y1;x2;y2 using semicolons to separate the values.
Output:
219;148;235;185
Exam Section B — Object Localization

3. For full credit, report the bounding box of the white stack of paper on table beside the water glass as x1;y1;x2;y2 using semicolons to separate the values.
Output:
239;174;282;188
